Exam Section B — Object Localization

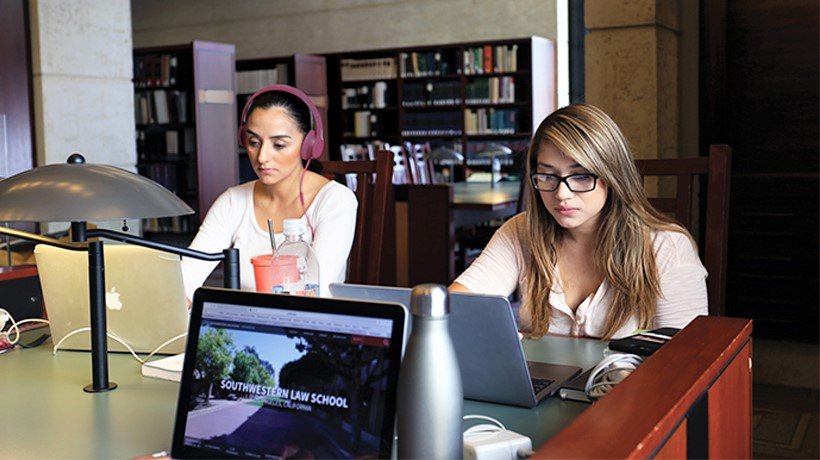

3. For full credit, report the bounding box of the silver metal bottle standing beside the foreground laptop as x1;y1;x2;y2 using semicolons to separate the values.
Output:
397;284;464;459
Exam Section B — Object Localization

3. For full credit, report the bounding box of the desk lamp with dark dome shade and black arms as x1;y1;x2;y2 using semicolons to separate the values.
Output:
0;153;239;393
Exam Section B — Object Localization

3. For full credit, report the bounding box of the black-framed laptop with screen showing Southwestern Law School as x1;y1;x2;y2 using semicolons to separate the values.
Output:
171;288;407;458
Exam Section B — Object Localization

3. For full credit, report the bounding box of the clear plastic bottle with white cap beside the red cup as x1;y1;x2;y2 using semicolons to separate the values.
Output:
271;219;319;296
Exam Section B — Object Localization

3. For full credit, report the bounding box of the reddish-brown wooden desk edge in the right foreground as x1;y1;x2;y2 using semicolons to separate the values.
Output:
535;316;752;458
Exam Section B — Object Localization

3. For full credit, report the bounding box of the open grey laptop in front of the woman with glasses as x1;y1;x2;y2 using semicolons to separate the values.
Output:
330;283;581;407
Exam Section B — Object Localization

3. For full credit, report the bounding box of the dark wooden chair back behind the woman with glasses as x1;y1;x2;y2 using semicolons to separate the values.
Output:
635;144;732;316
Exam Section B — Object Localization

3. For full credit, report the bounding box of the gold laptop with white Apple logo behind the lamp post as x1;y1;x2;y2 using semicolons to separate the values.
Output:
34;243;188;354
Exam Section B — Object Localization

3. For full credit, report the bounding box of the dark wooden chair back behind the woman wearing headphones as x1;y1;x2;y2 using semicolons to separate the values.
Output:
322;150;395;284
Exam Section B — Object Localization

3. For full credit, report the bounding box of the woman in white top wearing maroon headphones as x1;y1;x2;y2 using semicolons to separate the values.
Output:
182;85;358;300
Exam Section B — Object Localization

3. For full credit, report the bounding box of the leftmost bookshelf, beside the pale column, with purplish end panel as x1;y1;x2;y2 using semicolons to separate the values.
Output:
134;40;238;242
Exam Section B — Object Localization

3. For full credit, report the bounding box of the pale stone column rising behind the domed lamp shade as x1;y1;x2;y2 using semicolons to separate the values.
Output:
29;0;137;171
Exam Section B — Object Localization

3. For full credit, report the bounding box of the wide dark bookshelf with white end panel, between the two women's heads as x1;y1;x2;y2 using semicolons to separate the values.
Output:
327;37;556;168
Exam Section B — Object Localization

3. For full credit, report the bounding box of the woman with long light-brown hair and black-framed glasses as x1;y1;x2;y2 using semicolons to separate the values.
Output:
450;104;707;339
